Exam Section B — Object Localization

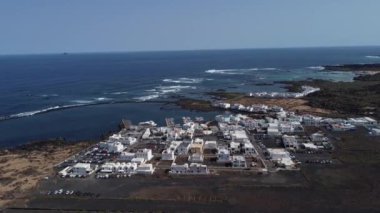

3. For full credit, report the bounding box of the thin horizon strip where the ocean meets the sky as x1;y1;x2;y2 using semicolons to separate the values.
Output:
0;44;380;56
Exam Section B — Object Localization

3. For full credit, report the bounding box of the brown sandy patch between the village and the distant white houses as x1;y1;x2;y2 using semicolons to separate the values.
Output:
227;97;334;116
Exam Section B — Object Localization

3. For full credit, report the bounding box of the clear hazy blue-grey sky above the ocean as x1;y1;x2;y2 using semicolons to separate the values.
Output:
0;0;380;54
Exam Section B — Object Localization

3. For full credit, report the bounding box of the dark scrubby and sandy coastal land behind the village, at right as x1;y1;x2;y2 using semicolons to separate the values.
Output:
176;68;380;119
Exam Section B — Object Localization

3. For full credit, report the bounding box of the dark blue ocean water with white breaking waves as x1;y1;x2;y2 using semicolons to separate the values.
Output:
0;47;380;147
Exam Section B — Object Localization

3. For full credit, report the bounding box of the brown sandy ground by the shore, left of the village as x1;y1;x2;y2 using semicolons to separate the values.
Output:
0;142;89;207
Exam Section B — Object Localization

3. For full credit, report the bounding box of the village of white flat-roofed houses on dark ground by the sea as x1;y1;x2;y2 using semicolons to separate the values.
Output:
57;102;380;179
